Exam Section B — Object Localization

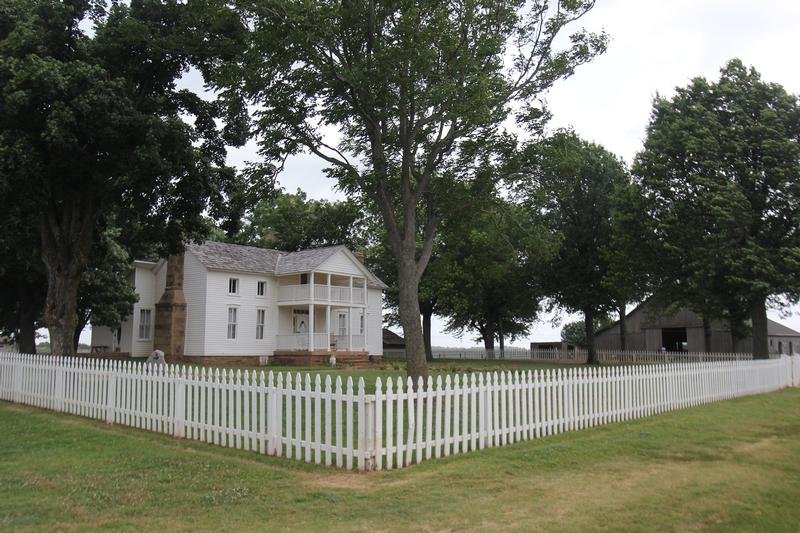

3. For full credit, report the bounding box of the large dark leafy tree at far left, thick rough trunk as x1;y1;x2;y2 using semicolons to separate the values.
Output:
0;0;242;355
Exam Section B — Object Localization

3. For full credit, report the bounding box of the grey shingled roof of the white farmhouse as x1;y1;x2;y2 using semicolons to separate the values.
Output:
186;241;386;289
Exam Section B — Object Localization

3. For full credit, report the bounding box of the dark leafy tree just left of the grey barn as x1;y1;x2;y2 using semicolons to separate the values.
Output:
520;131;629;364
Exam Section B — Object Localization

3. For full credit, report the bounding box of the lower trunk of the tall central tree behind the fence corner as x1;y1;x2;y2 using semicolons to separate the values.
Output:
398;259;428;386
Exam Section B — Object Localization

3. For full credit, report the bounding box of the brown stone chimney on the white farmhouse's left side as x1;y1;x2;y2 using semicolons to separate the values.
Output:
153;254;186;363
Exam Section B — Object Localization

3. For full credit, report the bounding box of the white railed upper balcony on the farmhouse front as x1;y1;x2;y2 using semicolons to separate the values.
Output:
278;272;367;305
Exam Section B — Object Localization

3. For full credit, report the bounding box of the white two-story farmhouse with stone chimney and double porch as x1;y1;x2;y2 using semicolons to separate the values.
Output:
92;242;386;364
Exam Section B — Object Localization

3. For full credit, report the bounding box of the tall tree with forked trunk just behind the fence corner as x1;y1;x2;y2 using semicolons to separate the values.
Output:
216;0;606;377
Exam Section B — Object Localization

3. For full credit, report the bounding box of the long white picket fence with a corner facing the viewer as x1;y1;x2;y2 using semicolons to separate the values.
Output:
0;353;800;470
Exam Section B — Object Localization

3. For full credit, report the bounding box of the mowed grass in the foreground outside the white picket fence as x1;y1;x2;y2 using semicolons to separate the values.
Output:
0;389;800;532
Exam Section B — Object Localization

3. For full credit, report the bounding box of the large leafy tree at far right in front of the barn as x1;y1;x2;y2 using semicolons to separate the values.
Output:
634;60;800;358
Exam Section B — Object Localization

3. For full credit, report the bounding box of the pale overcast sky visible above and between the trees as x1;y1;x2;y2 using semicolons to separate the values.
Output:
76;0;800;346
